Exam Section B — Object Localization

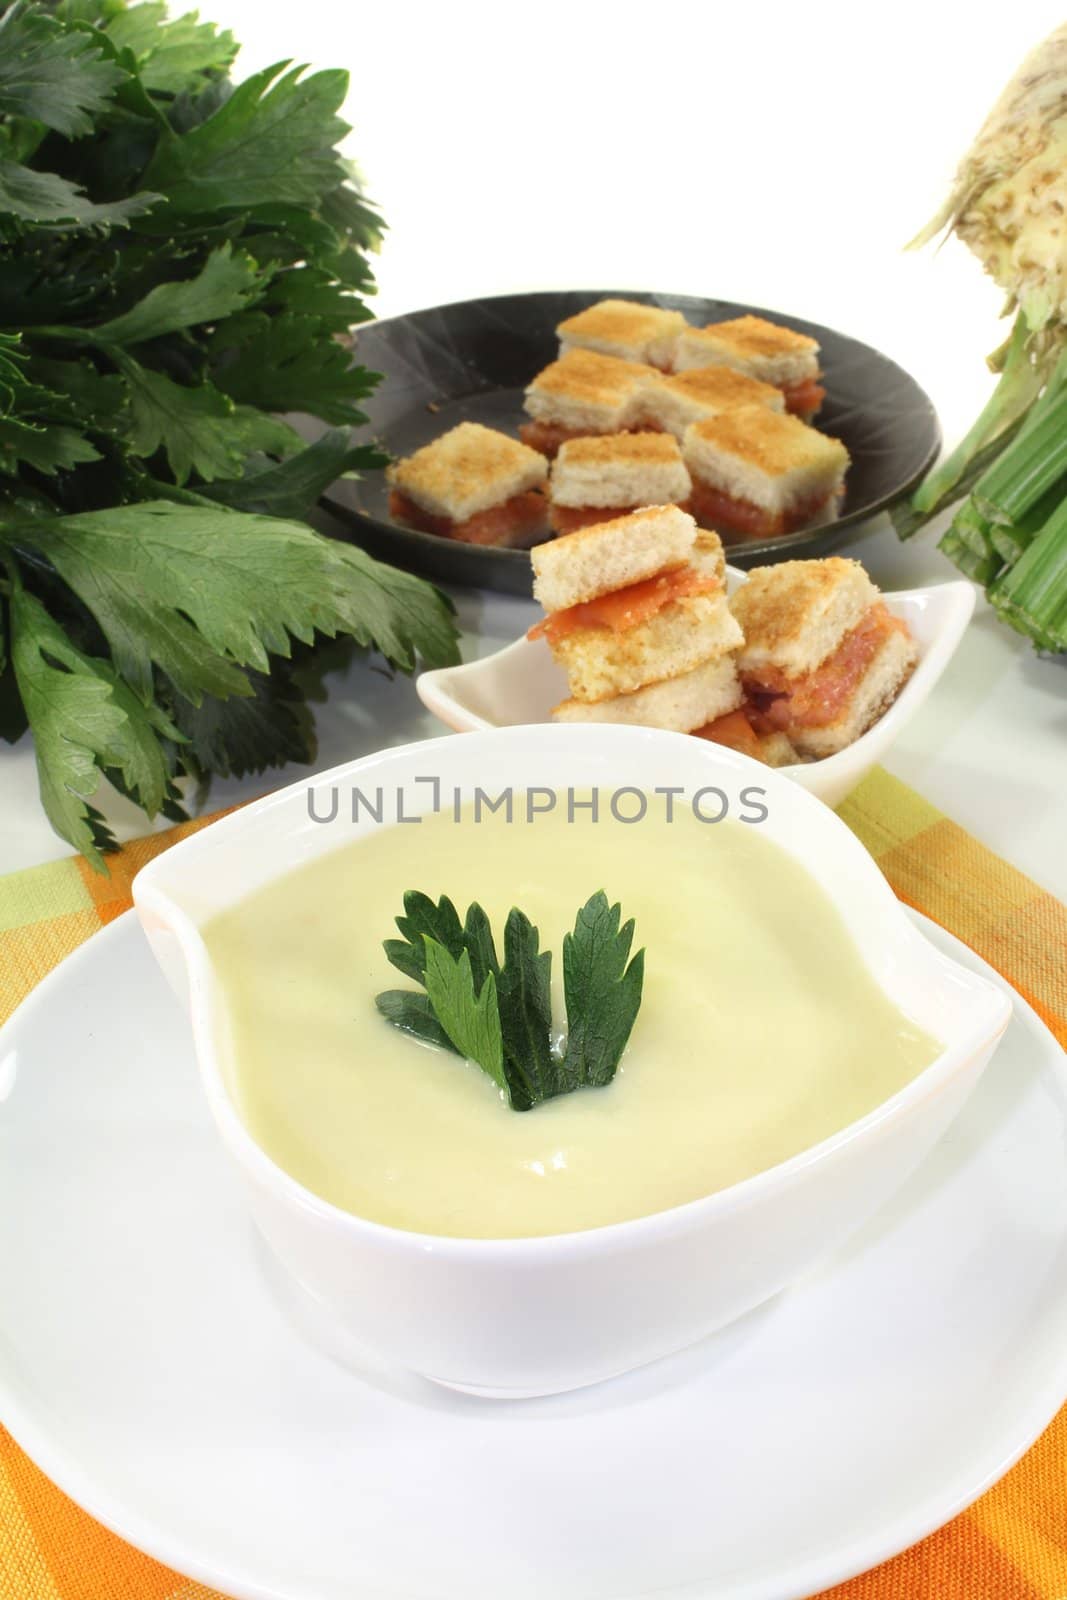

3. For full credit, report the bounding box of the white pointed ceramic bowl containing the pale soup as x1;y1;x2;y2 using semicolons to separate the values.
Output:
134;725;1009;1397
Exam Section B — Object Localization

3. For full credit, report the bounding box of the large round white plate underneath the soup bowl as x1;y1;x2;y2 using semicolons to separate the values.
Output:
0;917;1067;1600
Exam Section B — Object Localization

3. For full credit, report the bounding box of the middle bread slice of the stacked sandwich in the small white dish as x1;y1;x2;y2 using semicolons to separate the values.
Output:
552;590;742;704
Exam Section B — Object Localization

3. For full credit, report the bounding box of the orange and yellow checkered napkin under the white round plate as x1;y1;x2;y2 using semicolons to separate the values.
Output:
0;771;1067;1600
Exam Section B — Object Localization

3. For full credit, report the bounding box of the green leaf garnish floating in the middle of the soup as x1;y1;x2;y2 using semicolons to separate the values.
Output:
376;890;645;1110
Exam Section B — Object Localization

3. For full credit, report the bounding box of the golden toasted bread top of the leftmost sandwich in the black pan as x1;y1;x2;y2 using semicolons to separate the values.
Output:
386;422;549;522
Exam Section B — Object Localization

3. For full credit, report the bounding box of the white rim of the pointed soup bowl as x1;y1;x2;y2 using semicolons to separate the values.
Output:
131;723;1013;1266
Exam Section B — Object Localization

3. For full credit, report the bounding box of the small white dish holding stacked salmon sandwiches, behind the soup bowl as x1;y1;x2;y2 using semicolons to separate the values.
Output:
416;566;976;805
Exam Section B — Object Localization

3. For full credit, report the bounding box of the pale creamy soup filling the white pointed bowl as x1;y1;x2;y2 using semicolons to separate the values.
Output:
205;806;941;1238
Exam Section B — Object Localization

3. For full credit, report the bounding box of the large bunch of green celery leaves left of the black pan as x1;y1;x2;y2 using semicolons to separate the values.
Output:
0;0;456;866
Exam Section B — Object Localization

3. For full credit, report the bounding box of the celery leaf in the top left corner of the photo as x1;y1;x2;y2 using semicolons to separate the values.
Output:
0;3;126;139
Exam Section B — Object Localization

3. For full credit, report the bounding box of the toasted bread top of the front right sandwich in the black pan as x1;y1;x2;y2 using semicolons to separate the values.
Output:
681;406;849;512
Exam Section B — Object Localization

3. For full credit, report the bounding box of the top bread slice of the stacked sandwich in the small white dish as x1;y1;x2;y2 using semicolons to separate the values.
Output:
530;506;696;611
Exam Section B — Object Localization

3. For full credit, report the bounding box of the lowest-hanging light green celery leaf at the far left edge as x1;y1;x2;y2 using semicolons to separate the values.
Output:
11;582;176;869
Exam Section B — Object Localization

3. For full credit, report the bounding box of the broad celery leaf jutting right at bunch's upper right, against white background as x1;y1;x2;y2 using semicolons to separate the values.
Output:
144;62;349;213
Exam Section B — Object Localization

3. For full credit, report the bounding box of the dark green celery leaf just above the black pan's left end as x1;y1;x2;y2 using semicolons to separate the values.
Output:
213;314;379;426
